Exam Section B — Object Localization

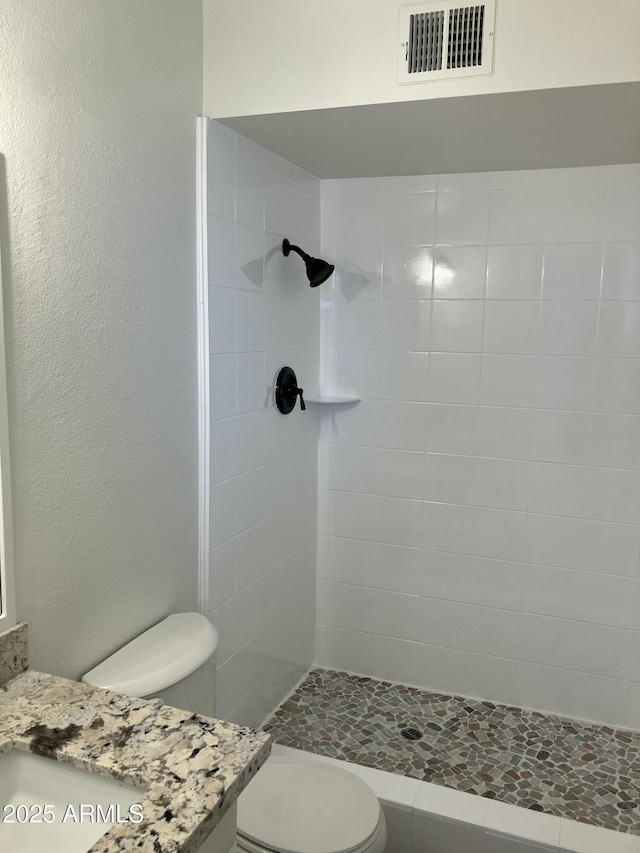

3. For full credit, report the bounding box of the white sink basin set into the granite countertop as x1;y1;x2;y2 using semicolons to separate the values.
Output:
0;749;143;853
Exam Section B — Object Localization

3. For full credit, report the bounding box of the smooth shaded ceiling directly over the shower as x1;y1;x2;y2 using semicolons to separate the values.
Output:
221;83;640;178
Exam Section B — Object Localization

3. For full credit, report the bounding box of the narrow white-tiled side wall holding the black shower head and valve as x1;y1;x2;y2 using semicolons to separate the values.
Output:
205;122;320;726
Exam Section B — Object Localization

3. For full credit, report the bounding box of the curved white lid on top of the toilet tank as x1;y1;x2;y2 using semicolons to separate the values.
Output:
82;613;218;698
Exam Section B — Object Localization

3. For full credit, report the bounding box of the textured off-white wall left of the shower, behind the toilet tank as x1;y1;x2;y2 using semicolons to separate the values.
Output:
0;0;202;676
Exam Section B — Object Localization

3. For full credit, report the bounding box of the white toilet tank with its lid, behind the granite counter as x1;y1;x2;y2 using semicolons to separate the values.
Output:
82;613;218;717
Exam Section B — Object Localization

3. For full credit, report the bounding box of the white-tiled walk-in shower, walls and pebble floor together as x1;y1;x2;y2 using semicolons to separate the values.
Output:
201;111;640;849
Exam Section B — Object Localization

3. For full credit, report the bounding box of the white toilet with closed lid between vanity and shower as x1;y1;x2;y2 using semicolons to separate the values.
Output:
82;613;387;853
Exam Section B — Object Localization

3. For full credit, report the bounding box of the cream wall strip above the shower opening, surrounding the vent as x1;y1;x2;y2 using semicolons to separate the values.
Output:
204;0;640;118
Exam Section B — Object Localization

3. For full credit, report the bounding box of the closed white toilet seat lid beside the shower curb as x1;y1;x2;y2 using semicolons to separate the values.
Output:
238;755;380;853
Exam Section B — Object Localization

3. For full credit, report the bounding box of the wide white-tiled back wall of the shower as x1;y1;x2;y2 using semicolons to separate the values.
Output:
316;161;640;728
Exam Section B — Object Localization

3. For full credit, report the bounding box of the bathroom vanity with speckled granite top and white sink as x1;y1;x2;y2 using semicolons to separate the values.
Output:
0;623;271;853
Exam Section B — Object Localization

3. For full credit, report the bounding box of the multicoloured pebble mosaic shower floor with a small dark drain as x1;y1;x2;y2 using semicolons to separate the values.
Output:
264;669;640;835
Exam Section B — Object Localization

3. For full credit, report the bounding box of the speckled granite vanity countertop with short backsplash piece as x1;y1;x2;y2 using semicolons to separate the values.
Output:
0;626;271;853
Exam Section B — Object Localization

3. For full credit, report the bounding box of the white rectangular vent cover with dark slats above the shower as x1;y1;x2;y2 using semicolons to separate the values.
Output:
398;0;496;83
